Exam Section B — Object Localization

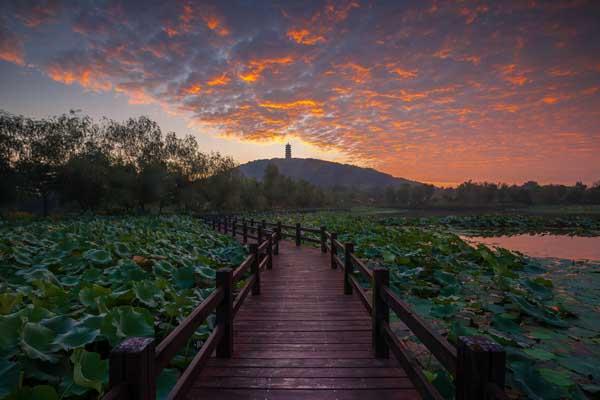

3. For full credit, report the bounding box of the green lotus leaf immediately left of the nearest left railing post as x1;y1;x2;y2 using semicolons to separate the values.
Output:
71;349;108;393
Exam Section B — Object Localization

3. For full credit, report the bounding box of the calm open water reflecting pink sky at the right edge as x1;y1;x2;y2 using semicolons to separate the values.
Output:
463;234;600;261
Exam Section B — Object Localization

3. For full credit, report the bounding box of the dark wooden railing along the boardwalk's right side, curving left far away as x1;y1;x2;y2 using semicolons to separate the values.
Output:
213;217;507;400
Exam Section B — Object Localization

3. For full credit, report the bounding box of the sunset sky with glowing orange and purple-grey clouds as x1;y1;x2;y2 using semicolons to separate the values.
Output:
0;0;600;185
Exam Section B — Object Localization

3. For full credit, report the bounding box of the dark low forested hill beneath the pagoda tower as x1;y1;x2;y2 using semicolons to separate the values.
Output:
240;158;418;188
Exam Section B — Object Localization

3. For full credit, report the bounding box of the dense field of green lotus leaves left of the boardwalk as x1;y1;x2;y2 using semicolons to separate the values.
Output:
0;216;245;400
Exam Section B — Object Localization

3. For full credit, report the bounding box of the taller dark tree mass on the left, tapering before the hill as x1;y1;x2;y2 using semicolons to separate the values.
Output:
0;111;336;215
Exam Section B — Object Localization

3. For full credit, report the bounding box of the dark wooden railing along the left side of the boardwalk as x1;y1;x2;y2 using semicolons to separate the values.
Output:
103;221;279;400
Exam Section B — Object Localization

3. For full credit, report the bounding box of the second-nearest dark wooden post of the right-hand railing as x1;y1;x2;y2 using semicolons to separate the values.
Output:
371;268;390;358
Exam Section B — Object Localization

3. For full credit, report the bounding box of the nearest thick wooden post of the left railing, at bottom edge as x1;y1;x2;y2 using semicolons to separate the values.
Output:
108;337;156;400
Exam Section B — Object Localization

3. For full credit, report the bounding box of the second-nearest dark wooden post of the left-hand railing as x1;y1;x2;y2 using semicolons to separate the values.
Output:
215;268;233;358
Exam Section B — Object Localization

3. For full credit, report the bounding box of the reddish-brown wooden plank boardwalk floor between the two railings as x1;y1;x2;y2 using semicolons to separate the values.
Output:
187;241;420;400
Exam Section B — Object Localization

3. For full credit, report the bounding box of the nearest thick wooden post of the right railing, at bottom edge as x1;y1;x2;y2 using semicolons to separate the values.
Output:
456;336;506;400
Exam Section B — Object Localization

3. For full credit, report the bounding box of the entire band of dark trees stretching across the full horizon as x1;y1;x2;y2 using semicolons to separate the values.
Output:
0;111;600;215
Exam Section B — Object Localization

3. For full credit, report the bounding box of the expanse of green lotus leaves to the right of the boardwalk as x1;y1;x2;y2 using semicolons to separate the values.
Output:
272;213;600;400
